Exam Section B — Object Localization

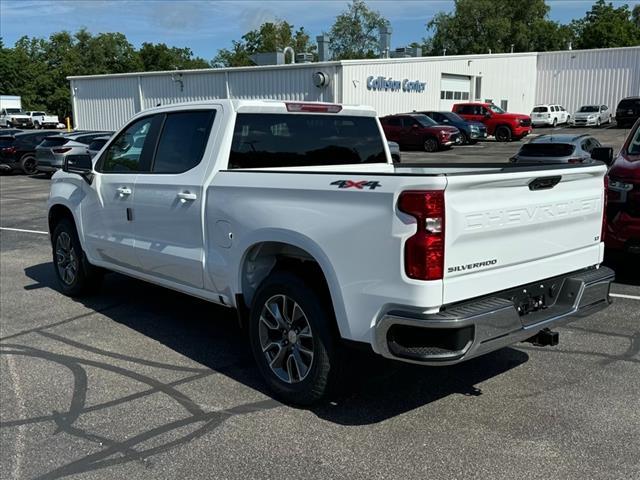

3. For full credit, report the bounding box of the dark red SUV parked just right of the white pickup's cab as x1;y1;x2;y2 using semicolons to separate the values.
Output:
380;113;462;152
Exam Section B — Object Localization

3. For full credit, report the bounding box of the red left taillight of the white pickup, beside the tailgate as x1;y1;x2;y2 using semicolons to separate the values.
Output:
398;190;444;280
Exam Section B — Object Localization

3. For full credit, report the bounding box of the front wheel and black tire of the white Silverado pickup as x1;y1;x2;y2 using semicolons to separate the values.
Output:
51;218;103;297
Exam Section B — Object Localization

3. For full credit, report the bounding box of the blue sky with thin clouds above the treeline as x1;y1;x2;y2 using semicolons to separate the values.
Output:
0;0;640;60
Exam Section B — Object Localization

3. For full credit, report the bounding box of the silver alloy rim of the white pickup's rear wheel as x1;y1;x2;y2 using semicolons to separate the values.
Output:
258;294;314;383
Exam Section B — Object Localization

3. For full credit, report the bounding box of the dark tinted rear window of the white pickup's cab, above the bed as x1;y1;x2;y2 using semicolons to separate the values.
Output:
229;113;387;168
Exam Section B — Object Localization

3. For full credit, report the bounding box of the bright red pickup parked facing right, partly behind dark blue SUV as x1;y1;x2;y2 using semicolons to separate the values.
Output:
451;102;531;142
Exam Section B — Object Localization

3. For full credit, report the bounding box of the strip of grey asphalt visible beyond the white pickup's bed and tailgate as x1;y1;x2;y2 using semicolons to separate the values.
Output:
401;124;629;163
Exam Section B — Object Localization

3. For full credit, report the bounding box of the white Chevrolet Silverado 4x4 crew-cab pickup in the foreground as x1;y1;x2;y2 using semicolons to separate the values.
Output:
48;100;613;404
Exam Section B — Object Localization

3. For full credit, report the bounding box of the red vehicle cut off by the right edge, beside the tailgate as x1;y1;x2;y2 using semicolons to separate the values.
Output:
605;120;640;254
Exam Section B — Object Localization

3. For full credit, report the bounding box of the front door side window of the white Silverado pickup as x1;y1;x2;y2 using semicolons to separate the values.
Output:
99;115;162;173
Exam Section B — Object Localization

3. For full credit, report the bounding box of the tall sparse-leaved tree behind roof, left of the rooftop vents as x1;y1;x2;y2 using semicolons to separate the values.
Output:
329;0;389;60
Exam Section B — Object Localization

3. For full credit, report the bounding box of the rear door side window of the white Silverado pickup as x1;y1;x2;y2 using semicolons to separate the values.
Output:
152;110;215;173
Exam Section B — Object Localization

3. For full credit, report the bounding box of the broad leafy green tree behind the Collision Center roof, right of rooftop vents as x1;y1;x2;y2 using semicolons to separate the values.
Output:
424;0;573;55
